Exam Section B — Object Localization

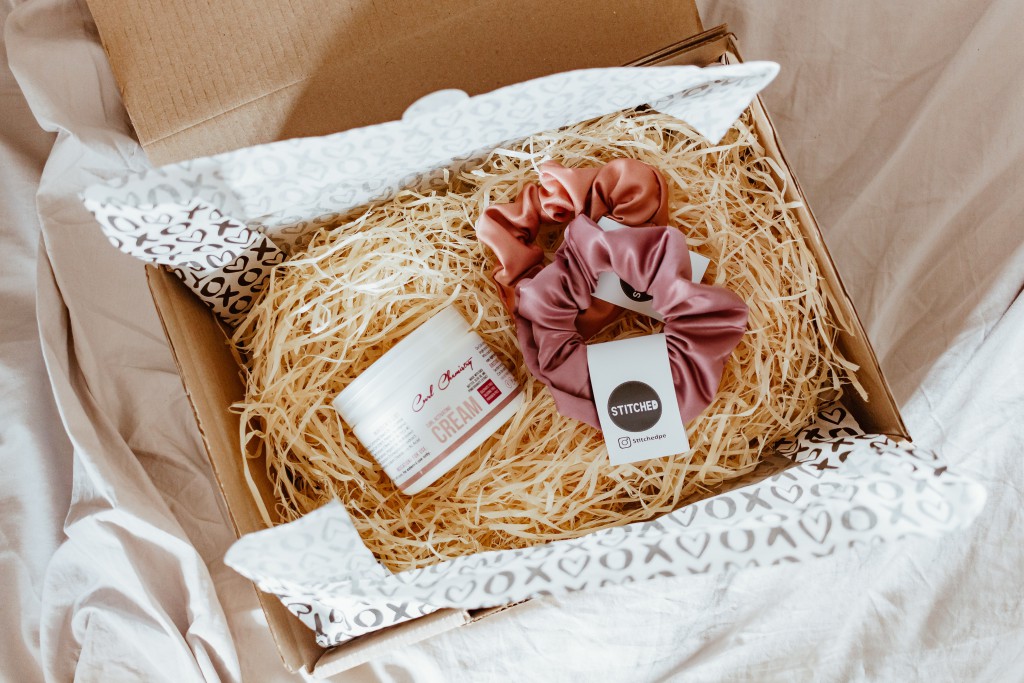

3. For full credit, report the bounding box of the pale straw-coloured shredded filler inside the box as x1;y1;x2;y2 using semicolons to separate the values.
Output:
233;110;860;571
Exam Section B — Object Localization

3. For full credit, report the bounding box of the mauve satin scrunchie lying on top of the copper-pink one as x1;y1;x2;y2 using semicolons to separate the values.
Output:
515;216;746;427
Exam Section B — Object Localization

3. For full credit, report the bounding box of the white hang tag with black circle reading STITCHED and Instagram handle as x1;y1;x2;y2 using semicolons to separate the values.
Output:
587;334;690;465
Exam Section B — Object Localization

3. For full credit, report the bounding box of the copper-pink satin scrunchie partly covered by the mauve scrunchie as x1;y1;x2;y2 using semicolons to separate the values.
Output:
476;159;669;339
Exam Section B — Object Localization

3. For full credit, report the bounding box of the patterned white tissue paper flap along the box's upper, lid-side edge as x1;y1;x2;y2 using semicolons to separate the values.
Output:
82;61;778;324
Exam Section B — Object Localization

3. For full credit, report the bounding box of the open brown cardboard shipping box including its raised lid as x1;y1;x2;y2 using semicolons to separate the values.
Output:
89;0;907;676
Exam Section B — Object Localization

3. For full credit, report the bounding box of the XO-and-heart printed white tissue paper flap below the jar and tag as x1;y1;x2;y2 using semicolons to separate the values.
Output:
224;405;985;647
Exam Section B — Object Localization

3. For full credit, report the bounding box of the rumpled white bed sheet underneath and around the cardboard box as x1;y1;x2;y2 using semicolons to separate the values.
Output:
0;0;1024;681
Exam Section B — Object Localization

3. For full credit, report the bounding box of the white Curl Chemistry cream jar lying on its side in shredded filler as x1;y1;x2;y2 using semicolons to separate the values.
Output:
334;306;523;495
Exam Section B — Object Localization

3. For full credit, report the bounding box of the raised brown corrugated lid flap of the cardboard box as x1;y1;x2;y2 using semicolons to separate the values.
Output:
88;0;700;164
